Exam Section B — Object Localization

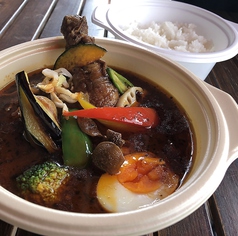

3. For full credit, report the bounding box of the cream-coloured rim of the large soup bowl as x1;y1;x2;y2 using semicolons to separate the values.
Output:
0;37;232;236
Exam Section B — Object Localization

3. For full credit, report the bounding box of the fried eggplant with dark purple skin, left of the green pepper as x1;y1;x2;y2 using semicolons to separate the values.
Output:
15;71;61;153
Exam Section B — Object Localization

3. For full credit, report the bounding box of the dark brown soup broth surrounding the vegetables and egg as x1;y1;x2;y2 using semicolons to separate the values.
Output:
0;67;193;213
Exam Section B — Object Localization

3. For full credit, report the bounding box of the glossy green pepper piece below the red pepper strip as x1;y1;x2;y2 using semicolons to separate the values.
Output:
62;117;92;168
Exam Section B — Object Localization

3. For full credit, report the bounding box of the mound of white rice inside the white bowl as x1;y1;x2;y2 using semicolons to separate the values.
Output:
122;21;214;53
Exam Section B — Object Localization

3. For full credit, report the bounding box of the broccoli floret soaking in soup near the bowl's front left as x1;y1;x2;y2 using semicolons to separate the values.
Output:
16;162;70;203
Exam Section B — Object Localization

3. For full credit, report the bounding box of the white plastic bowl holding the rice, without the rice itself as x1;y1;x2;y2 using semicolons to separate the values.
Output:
92;0;238;80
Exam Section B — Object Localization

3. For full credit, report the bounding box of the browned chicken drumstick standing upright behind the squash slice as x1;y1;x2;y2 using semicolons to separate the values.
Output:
61;15;119;107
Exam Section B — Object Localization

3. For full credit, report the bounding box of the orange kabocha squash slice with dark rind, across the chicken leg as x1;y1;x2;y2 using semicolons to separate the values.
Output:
54;43;107;72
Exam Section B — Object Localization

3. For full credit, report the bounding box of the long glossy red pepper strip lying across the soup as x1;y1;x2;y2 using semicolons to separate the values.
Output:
63;107;159;128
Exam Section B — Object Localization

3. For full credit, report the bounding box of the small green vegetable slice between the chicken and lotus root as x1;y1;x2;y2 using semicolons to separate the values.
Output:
107;67;133;94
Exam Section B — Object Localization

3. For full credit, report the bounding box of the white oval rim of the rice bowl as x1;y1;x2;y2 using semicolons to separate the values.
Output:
106;0;238;63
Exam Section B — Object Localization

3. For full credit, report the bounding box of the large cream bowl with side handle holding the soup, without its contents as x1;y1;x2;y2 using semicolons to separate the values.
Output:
0;37;238;236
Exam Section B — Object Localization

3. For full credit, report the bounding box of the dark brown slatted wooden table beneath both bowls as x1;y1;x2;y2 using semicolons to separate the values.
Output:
0;0;238;236
